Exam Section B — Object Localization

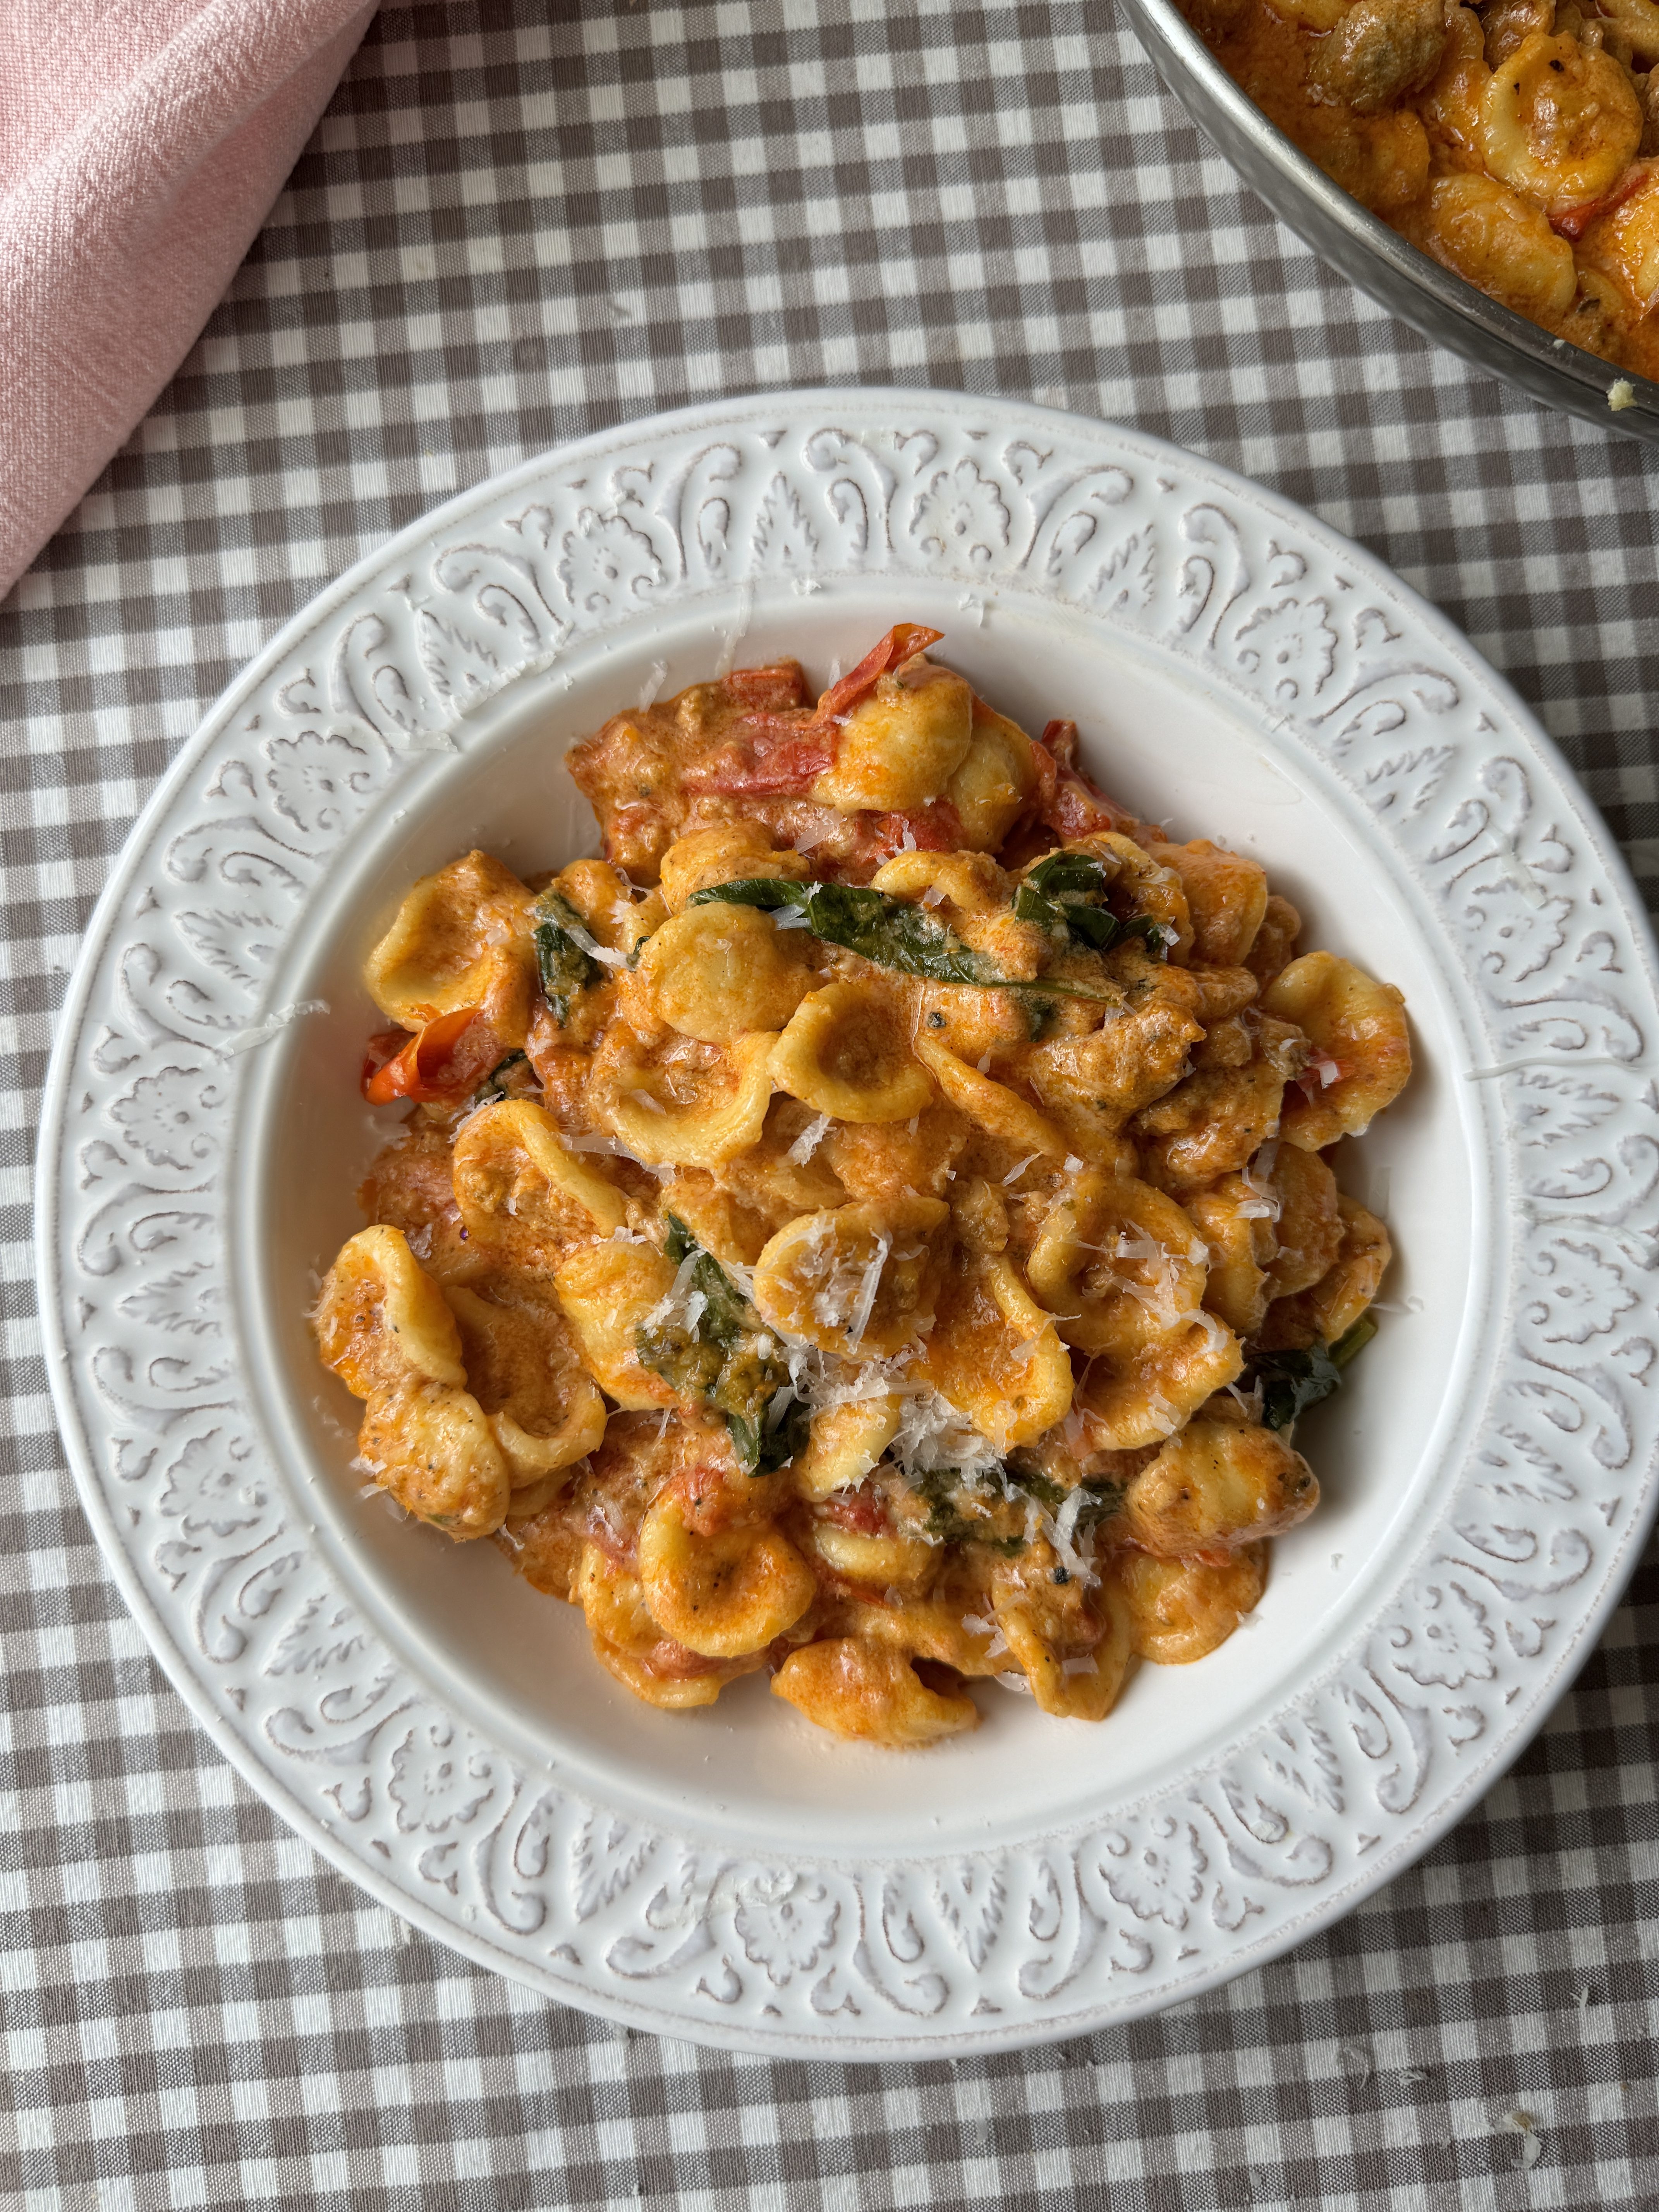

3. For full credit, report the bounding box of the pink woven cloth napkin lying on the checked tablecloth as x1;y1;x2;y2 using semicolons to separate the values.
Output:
0;0;374;595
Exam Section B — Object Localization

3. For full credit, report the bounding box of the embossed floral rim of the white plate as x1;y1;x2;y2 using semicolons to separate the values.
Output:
38;392;1659;2057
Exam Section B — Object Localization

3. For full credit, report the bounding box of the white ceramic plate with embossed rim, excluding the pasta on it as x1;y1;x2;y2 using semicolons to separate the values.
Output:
40;392;1659;2057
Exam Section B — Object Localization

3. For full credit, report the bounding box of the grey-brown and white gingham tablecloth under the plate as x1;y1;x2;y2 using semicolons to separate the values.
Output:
0;0;1659;2212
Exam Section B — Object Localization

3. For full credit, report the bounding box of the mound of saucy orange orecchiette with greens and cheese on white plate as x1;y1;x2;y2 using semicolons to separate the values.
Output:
316;624;1411;1747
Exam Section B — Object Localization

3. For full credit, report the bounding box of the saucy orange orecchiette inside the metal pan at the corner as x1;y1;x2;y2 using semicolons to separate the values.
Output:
1179;0;1659;376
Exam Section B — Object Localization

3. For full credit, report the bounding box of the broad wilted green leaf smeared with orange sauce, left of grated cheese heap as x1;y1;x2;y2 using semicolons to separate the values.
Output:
637;1214;807;1475
